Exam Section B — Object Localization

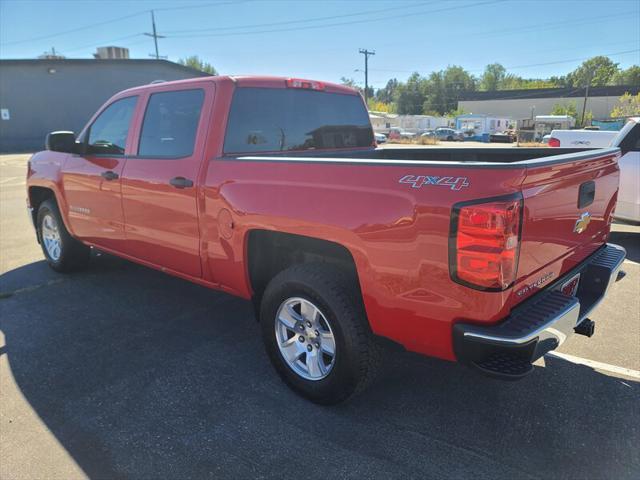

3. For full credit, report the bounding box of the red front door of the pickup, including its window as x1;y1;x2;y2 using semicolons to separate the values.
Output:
62;96;138;250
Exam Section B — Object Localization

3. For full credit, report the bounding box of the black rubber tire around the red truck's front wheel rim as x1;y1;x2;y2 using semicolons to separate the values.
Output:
36;200;91;273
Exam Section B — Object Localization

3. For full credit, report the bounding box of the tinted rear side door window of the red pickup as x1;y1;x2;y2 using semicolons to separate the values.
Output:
138;89;204;158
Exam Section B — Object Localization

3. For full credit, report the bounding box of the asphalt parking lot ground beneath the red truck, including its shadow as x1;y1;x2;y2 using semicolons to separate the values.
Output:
0;155;640;479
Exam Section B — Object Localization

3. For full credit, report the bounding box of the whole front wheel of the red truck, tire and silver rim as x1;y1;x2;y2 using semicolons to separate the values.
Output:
37;200;90;272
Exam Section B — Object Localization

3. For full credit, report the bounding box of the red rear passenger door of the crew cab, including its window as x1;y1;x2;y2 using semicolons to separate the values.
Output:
122;82;214;277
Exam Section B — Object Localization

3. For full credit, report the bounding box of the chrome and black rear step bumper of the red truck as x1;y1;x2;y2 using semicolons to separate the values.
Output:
453;244;626;380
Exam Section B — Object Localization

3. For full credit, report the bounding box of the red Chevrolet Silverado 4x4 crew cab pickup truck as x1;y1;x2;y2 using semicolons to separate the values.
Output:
27;76;625;404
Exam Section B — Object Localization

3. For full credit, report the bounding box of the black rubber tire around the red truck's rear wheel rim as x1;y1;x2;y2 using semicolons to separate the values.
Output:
260;263;382;405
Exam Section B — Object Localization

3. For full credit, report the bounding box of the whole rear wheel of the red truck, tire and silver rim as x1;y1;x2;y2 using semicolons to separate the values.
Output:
260;264;381;404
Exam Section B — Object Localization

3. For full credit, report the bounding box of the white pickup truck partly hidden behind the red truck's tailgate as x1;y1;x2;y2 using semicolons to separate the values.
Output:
549;121;640;223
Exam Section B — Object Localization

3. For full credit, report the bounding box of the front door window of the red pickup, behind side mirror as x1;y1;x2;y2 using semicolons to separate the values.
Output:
87;97;138;155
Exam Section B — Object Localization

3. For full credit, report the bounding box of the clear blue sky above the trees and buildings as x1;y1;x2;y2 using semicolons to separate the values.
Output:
0;0;640;88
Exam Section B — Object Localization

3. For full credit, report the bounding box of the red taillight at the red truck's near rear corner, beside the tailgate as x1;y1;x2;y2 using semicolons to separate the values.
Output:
449;195;522;291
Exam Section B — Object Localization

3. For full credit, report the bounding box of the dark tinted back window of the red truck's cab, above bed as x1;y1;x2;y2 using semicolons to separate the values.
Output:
224;87;373;154
